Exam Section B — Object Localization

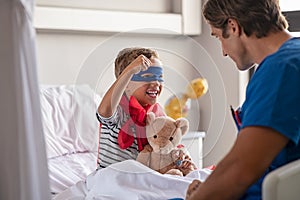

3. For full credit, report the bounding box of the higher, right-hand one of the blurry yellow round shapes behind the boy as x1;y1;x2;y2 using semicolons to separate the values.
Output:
186;78;208;99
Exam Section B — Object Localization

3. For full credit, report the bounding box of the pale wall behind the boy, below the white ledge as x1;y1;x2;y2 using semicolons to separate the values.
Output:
37;1;239;166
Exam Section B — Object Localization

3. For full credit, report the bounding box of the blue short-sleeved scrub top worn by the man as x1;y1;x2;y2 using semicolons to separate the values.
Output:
237;38;300;200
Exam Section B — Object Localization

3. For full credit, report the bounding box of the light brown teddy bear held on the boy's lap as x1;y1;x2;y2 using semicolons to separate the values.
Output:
136;112;196;176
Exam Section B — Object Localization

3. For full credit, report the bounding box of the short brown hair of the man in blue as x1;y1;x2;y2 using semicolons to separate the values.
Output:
203;0;288;38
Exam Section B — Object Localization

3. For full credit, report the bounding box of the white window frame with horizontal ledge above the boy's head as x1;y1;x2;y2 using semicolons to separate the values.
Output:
34;0;201;35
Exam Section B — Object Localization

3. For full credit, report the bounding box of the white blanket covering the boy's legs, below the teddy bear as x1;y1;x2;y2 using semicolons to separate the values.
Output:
54;160;211;200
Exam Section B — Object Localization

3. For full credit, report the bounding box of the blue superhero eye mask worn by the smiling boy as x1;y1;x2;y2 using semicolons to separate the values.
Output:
131;66;164;82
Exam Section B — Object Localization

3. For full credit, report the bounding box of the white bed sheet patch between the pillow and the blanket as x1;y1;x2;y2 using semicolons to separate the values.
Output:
48;152;97;194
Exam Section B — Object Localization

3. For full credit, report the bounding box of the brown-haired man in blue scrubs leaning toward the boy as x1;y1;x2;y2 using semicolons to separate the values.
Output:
186;0;300;200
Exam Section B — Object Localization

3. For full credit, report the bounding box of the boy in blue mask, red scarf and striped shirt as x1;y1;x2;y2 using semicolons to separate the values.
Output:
97;47;170;169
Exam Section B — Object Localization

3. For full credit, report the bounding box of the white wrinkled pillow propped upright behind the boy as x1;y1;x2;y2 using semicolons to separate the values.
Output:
40;85;101;158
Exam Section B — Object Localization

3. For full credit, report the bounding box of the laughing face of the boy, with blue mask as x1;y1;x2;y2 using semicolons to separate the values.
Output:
126;59;163;106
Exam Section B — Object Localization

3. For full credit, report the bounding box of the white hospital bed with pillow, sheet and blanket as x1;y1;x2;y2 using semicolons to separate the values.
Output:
40;85;211;200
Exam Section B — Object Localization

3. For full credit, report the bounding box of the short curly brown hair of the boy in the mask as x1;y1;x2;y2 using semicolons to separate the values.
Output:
115;47;159;78
